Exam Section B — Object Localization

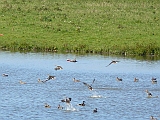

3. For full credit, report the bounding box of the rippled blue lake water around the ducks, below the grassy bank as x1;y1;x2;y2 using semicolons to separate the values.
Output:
0;51;160;120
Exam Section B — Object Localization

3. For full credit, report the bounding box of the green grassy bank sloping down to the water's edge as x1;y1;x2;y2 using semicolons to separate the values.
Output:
0;0;160;55
